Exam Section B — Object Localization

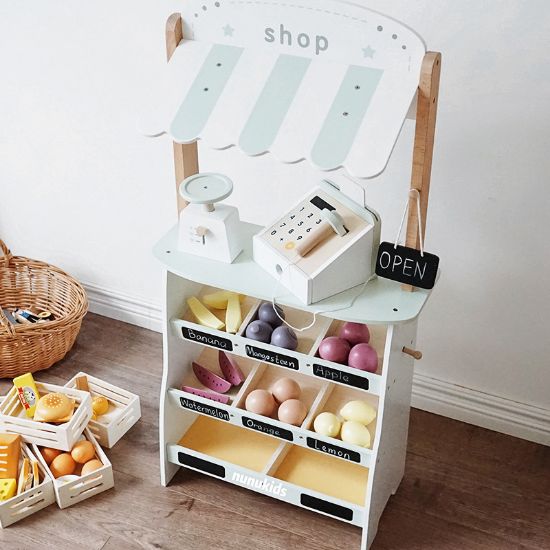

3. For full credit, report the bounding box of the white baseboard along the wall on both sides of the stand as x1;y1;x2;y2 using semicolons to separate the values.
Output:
84;284;550;445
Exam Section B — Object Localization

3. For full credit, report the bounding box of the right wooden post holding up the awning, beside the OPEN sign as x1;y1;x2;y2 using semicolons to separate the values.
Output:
402;52;441;291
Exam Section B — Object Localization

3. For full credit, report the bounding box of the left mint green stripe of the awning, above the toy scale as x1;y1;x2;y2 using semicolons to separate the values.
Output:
170;44;243;143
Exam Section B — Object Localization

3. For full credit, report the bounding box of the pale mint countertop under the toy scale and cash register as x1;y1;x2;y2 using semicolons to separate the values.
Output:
154;223;430;324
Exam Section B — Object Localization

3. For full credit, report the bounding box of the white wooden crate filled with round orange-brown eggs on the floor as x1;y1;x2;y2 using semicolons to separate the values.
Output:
33;428;115;509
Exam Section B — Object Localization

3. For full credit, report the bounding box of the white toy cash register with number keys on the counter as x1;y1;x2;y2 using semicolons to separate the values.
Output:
254;180;380;304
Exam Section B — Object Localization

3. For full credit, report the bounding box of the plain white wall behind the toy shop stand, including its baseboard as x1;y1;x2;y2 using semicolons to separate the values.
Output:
0;0;550;443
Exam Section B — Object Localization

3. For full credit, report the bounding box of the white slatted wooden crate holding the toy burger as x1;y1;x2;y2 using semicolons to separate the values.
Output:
0;382;92;451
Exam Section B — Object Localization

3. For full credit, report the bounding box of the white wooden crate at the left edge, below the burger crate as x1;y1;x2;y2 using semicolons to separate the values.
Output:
0;444;55;529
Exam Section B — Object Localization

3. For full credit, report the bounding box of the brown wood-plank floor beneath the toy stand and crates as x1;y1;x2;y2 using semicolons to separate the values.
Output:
0;314;550;550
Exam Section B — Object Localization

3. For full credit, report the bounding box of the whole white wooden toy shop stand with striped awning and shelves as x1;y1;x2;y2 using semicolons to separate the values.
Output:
141;0;441;548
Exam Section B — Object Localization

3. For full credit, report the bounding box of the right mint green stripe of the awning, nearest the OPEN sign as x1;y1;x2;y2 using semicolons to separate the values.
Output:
311;65;384;170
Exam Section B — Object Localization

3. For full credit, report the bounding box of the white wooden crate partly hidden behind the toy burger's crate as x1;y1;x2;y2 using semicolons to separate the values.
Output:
65;372;141;449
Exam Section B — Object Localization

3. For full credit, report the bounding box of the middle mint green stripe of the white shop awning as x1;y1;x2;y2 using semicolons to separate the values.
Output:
239;54;311;155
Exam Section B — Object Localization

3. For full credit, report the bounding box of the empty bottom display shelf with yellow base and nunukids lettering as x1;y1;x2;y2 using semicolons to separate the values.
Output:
167;417;368;525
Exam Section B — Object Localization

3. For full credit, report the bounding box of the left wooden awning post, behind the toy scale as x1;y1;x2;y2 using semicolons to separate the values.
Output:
166;13;199;214
